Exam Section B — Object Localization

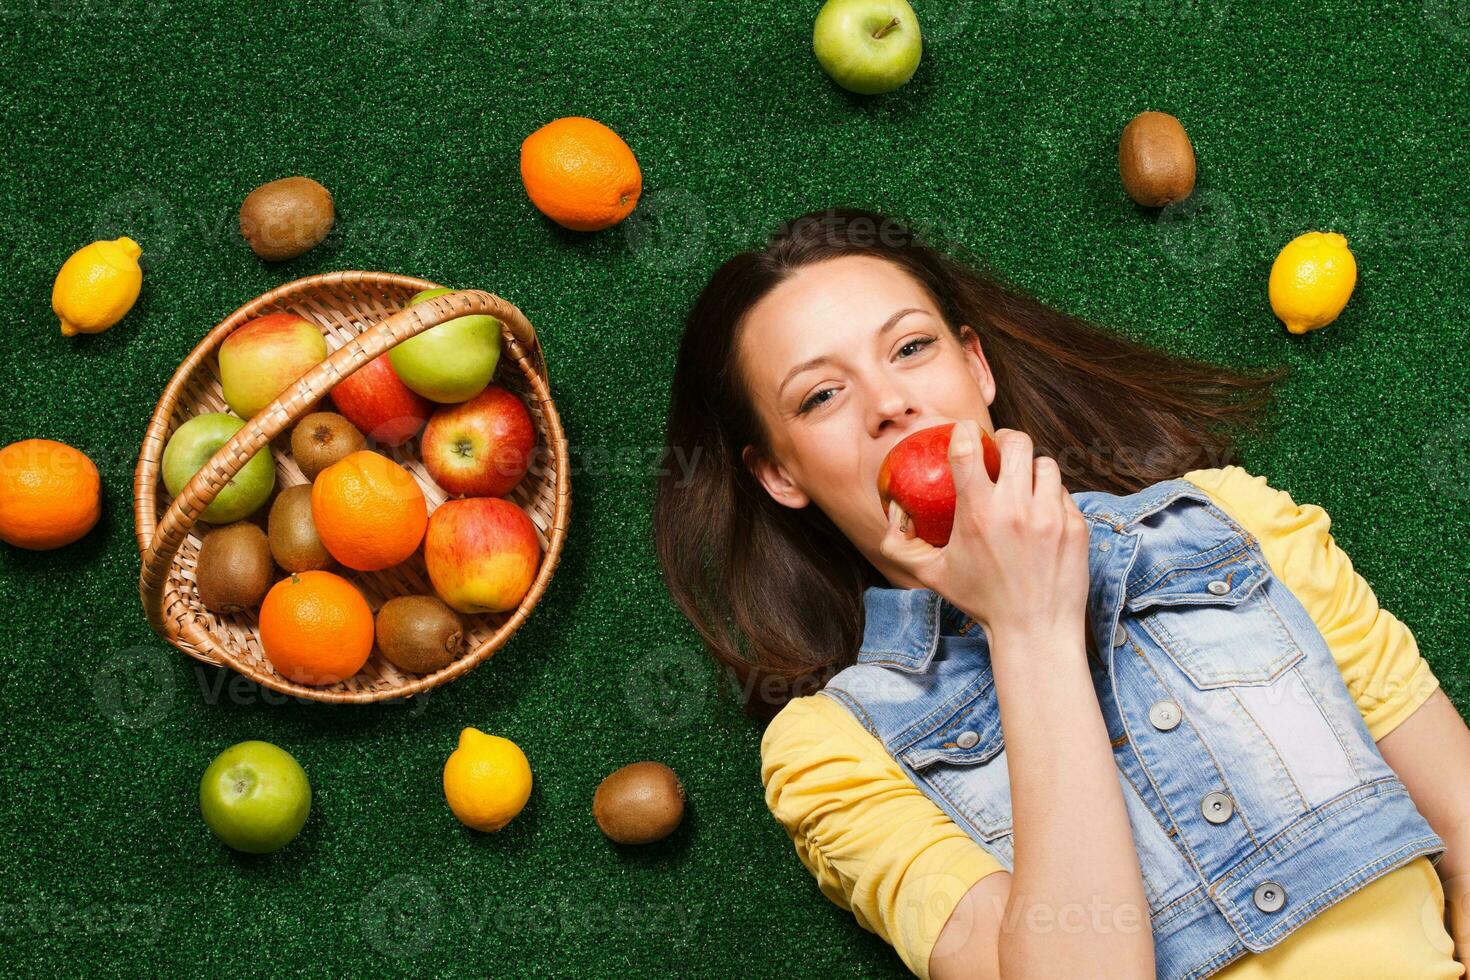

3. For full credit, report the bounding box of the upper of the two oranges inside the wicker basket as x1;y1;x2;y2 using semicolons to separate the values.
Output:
312;450;429;572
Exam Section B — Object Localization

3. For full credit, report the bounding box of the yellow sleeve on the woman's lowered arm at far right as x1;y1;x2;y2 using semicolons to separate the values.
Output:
1185;466;1439;741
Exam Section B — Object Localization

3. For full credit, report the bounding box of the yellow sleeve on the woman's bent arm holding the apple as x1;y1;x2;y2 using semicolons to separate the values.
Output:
760;695;1004;980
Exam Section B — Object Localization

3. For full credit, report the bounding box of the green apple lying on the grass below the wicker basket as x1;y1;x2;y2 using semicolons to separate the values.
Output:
198;742;312;854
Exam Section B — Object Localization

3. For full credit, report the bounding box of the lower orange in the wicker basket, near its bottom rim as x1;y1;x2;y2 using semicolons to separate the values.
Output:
260;572;372;685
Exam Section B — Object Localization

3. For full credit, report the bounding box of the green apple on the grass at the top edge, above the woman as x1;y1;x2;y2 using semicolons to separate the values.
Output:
811;0;923;96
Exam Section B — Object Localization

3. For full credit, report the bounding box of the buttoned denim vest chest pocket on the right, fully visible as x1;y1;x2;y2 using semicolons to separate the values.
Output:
1123;538;1305;691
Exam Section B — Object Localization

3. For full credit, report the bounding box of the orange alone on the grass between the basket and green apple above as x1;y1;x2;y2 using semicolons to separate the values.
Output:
520;116;642;231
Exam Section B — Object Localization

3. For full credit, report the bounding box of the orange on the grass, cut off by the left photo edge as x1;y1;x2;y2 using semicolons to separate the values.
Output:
0;439;101;551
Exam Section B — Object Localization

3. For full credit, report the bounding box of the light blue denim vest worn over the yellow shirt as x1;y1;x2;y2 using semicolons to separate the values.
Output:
820;479;1445;980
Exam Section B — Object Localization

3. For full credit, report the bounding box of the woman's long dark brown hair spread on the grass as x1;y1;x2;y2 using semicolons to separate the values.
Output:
653;207;1285;718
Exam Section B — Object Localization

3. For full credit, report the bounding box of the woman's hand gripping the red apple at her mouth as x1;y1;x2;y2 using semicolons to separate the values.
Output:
879;420;1088;649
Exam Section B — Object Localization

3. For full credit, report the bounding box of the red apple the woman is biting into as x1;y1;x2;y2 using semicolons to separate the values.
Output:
878;422;1001;548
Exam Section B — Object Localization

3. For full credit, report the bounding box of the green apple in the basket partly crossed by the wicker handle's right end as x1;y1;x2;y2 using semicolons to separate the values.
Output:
388;287;500;404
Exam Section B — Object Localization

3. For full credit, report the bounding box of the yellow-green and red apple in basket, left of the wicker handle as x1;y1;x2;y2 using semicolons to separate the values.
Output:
219;313;326;419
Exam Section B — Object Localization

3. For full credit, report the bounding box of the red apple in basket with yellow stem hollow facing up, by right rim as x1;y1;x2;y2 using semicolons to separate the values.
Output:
423;385;537;497
